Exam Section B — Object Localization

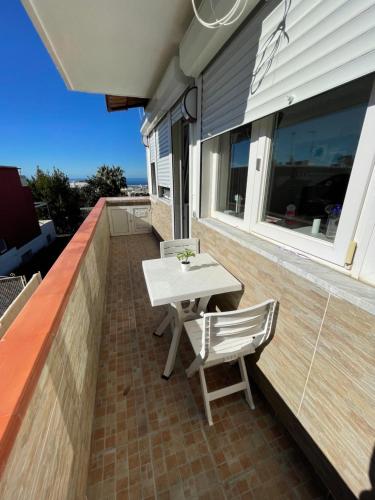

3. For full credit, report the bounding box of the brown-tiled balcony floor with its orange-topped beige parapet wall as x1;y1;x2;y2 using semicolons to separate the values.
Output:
0;200;352;500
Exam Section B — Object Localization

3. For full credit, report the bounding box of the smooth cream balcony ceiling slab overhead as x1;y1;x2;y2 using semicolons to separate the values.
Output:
22;0;193;98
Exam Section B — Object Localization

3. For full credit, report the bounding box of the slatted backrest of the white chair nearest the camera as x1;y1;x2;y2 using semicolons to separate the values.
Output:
200;300;276;360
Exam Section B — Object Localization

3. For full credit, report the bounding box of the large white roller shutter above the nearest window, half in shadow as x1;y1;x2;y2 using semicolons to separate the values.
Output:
202;0;375;139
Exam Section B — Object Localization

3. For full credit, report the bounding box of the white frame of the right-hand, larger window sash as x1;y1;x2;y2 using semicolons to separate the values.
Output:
250;78;375;266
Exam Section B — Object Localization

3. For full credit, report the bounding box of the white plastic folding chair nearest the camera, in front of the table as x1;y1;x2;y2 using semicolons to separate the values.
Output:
184;300;276;425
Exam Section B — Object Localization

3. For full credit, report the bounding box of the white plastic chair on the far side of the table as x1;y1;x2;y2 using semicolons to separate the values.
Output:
154;238;199;337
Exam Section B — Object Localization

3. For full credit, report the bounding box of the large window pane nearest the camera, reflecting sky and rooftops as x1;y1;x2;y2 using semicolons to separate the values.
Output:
263;76;372;241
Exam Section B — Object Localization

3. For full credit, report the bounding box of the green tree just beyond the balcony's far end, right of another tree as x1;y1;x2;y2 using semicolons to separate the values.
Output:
81;165;127;207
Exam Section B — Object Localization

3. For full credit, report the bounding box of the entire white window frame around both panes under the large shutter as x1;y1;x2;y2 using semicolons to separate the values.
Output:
202;78;375;267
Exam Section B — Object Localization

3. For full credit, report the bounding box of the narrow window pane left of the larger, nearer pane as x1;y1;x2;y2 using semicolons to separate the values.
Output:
216;125;251;219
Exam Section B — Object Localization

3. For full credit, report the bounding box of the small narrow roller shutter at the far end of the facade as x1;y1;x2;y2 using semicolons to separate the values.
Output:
156;114;171;188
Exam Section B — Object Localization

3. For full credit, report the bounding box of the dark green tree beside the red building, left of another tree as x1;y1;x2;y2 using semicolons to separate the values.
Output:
28;167;82;234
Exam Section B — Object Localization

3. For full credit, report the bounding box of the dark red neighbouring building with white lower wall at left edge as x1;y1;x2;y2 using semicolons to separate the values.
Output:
0;166;56;275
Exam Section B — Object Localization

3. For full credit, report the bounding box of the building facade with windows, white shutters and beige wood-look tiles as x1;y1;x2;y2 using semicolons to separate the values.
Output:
141;1;375;495
